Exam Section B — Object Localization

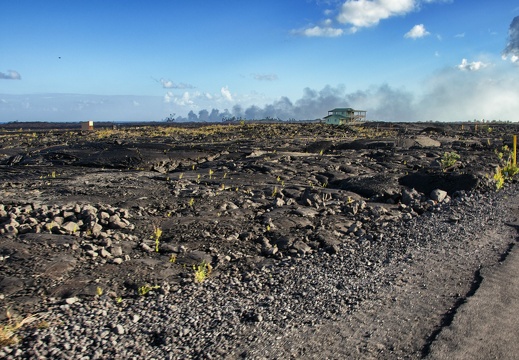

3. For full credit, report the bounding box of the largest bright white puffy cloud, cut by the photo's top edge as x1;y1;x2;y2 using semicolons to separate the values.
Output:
337;0;417;30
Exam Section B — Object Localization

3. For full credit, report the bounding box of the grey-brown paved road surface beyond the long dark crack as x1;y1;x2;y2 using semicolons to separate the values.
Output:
428;246;519;359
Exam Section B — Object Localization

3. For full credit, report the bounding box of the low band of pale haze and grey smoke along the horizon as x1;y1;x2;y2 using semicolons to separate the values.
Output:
0;64;519;122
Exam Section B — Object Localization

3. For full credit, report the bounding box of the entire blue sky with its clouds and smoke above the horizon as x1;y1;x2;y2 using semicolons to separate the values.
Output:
0;0;519;122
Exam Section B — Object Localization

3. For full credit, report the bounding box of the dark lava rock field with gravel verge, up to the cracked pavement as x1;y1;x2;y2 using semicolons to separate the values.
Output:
0;123;519;359
